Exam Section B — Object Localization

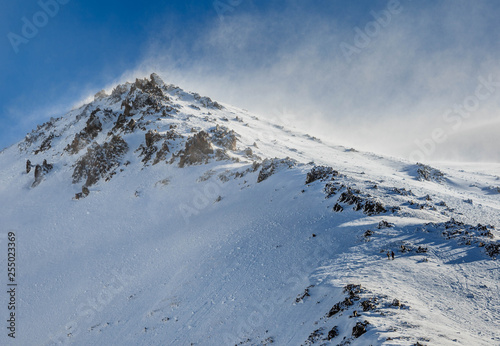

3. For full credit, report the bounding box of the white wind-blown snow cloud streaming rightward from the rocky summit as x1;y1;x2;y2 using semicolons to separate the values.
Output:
123;0;500;161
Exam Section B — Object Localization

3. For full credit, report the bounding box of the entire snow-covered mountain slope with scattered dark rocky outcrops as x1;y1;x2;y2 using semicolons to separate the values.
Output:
0;74;500;345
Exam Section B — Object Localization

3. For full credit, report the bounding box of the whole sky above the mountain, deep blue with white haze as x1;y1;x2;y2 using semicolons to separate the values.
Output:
0;0;500;161
